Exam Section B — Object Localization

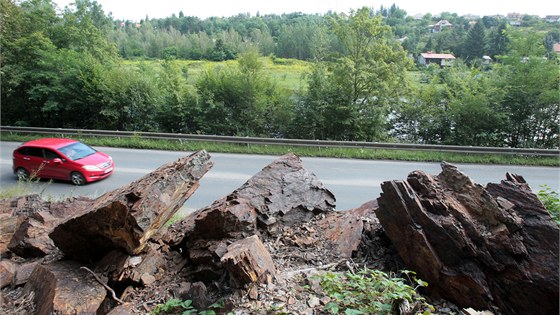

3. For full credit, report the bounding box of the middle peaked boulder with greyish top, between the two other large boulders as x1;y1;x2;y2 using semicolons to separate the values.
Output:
168;154;336;243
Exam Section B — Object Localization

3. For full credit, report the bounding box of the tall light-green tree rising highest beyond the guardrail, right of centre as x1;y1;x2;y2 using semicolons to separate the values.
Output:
316;8;409;140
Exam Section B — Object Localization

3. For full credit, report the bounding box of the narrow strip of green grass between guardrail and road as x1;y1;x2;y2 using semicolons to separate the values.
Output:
0;132;560;167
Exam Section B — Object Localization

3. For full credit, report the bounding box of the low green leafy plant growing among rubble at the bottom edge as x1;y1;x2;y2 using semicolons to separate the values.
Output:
318;268;433;314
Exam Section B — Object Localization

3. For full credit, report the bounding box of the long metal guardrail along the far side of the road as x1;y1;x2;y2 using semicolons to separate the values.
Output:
0;126;560;157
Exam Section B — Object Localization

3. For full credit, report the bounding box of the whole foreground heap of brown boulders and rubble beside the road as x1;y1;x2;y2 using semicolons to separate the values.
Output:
0;156;558;314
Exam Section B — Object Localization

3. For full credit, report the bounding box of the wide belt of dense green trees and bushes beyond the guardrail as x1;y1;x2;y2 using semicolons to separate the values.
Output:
0;0;560;148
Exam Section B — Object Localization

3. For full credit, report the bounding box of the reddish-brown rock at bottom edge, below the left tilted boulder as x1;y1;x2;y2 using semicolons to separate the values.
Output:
24;262;106;315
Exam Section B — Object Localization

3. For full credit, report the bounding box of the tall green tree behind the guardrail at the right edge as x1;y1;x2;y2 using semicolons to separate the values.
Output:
495;29;560;148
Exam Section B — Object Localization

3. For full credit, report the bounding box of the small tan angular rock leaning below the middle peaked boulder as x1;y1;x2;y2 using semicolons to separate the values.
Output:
222;235;276;287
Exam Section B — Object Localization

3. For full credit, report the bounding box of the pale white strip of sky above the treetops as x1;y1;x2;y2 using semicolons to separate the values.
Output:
53;0;560;21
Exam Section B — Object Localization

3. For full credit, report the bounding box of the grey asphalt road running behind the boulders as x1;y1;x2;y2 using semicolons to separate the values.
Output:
0;141;560;211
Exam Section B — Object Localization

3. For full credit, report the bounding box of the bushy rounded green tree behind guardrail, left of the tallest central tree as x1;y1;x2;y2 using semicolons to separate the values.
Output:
196;49;287;136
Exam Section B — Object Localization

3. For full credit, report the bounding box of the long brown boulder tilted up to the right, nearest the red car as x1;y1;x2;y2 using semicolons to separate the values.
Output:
50;151;212;261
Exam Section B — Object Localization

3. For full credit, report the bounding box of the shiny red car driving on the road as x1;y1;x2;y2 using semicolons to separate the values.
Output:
13;138;115;185
